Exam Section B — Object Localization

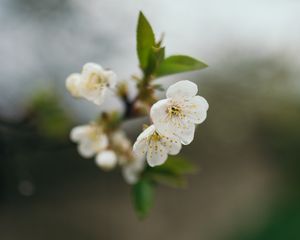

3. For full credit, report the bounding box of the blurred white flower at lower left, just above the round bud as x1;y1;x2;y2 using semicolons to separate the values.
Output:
70;124;108;158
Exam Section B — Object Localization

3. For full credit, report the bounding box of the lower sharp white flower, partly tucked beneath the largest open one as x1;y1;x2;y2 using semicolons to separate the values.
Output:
133;125;181;167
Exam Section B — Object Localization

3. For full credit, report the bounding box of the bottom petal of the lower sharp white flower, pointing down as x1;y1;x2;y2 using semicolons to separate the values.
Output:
147;141;168;167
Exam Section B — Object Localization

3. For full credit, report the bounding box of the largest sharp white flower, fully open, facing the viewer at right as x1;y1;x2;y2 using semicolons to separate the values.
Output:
150;80;208;145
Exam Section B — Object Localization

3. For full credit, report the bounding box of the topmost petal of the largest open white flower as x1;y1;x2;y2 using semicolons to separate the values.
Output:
166;80;198;99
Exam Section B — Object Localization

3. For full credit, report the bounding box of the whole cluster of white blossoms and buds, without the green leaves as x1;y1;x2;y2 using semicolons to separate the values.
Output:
66;63;208;184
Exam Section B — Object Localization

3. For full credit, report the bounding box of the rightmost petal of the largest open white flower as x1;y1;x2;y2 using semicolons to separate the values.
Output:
184;96;208;124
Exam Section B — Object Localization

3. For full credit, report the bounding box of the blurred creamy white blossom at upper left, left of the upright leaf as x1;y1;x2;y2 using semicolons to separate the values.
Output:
66;63;116;105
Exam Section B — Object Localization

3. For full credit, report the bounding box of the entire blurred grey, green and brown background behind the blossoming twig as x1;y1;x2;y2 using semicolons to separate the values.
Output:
0;0;300;240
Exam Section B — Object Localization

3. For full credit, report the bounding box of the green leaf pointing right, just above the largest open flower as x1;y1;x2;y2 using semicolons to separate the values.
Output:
156;55;207;77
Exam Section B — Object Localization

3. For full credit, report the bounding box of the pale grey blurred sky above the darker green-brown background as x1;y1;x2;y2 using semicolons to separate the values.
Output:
0;0;300;115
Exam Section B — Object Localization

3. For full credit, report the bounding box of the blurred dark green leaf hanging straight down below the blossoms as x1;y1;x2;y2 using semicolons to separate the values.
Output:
133;179;154;218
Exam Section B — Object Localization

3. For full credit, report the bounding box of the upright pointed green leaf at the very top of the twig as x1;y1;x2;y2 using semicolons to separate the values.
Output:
136;12;155;71
